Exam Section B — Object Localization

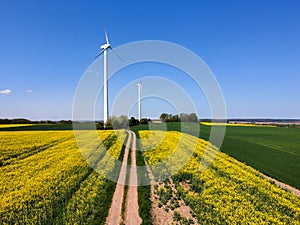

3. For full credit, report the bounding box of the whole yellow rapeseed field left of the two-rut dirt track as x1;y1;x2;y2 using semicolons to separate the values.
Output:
0;131;126;224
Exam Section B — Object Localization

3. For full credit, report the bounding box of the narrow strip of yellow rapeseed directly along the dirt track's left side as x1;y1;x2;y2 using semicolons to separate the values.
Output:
59;132;126;224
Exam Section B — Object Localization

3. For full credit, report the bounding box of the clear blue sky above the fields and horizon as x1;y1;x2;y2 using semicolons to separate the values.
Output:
0;0;300;120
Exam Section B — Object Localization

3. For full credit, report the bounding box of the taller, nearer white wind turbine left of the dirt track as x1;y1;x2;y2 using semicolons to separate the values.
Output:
95;26;124;127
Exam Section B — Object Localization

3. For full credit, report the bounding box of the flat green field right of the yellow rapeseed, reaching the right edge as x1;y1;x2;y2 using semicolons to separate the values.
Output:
132;123;300;189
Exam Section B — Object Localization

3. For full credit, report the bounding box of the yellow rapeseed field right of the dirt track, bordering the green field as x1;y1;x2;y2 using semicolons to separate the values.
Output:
139;131;300;224
